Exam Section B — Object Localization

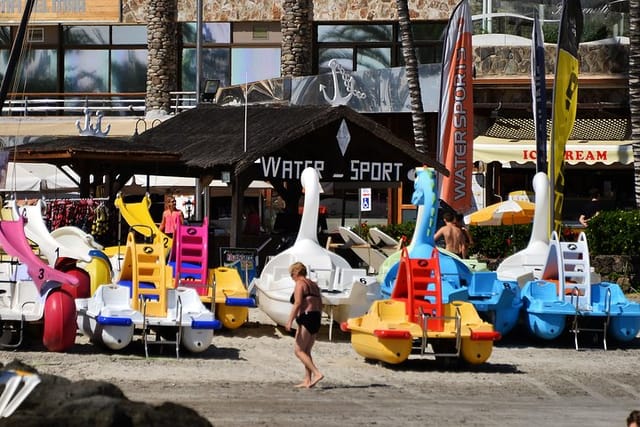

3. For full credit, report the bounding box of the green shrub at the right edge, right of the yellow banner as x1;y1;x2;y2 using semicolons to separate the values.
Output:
585;209;640;255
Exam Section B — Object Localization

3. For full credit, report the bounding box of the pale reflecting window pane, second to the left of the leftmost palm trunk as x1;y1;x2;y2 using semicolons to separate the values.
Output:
64;49;109;92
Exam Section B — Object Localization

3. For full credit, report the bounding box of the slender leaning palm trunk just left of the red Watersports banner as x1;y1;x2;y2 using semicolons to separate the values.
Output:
396;0;427;153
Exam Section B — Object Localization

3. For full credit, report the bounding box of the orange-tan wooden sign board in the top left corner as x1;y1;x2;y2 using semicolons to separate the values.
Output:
0;0;120;23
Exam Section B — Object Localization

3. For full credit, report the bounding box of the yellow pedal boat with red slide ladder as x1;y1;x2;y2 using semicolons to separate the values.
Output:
341;248;500;365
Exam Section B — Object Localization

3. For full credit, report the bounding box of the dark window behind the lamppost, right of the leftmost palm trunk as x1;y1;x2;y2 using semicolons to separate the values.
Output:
182;48;231;91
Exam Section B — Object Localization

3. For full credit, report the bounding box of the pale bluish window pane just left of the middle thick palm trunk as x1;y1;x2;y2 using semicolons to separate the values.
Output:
231;47;280;85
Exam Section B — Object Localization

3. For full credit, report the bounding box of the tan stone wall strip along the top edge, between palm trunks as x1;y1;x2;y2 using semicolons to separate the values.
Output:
122;0;458;23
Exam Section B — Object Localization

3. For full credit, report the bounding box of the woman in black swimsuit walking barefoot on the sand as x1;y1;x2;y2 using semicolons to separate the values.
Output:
286;262;324;388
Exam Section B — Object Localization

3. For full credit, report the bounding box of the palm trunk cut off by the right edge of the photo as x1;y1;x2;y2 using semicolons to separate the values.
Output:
629;0;640;208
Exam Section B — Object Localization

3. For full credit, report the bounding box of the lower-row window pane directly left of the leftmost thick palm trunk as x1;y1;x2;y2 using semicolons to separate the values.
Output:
111;49;147;93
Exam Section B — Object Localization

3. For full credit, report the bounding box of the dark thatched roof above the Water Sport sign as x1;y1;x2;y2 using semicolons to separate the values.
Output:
133;104;445;174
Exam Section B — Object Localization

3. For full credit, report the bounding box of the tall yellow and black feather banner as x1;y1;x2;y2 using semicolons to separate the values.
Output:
549;0;582;233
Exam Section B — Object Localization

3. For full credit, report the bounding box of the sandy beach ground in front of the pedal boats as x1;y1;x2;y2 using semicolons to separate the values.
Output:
0;309;640;426
